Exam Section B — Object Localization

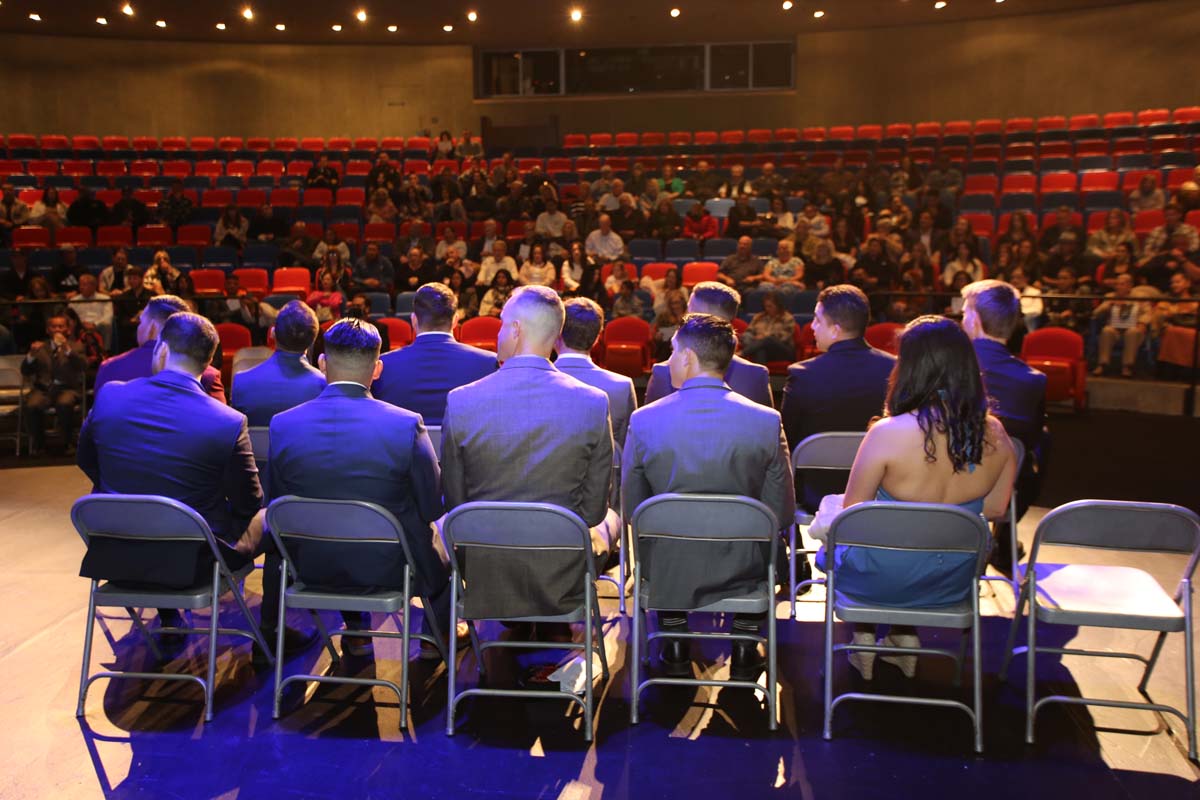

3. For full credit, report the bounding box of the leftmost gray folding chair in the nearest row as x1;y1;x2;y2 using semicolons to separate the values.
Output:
71;494;272;722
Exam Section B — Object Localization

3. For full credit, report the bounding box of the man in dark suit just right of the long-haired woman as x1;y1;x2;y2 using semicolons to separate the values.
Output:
962;281;1049;576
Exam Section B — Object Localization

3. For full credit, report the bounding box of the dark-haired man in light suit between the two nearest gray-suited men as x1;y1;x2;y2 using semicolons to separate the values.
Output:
554;297;637;450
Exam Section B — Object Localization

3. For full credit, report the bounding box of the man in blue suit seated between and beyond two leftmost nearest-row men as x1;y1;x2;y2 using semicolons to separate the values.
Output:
230;300;325;428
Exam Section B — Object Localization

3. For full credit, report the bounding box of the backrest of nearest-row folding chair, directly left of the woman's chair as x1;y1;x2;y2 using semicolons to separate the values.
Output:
631;494;779;544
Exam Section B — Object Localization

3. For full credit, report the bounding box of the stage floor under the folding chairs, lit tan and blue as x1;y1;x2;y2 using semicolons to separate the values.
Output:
0;467;1200;800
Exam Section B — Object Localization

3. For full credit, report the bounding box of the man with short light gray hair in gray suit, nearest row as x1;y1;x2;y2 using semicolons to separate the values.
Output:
442;285;620;619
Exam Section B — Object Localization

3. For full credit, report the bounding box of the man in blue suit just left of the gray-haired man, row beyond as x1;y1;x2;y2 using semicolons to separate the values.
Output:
371;283;496;425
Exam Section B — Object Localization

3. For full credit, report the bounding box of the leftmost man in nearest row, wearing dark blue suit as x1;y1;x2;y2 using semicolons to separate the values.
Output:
78;312;313;655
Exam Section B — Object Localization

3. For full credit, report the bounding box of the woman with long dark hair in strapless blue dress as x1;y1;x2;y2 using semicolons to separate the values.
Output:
817;317;1016;679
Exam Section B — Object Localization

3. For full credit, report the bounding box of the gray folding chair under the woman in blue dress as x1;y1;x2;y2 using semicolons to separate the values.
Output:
824;503;991;752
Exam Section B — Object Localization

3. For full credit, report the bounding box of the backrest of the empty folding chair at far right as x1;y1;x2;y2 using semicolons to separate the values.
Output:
1030;500;1200;568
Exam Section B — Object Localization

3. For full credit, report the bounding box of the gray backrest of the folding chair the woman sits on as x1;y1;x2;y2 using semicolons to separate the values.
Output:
826;503;991;576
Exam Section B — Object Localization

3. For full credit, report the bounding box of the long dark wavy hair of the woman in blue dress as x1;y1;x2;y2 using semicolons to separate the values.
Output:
884;315;988;473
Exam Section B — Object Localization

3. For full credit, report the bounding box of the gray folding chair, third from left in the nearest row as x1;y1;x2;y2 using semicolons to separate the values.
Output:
443;501;608;741
